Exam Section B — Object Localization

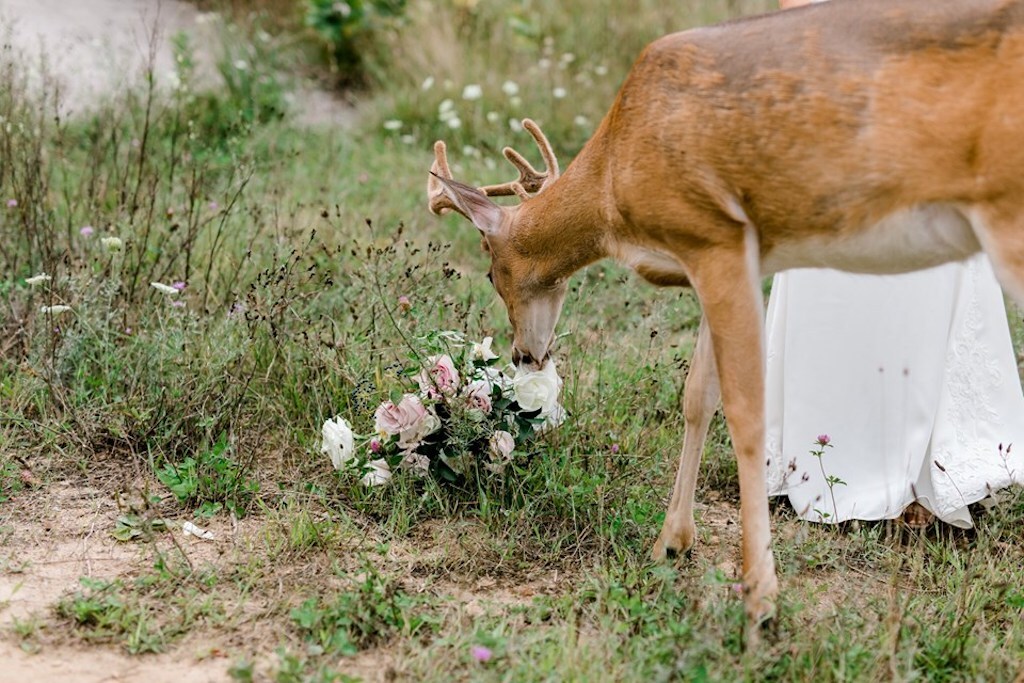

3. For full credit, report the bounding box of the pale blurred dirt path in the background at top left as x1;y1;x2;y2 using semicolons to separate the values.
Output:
0;0;354;127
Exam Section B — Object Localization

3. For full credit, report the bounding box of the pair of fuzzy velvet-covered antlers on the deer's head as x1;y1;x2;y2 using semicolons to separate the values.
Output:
427;119;559;215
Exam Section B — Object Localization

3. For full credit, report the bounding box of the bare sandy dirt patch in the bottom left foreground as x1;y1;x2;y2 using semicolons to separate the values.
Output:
0;483;230;683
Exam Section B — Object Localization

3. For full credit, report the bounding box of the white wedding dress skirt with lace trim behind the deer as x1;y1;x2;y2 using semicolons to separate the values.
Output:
766;255;1024;527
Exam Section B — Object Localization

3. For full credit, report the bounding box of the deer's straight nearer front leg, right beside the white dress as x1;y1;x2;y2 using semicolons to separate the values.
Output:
691;237;778;644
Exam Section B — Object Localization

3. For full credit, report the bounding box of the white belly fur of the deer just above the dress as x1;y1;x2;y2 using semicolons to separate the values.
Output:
761;204;981;274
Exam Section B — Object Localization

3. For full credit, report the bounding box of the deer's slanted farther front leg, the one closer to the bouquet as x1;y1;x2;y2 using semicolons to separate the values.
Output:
651;317;721;560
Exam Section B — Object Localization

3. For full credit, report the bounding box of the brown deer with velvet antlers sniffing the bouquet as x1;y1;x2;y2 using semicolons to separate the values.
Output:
427;0;1024;644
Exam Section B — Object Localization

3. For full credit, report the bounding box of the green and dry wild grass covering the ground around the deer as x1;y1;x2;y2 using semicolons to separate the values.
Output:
0;0;1024;681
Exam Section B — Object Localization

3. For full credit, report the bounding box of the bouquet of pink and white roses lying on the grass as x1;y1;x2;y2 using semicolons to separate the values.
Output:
321;332;565;486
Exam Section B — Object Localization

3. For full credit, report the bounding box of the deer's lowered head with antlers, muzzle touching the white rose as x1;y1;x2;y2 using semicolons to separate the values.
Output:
427;119;569;370
